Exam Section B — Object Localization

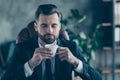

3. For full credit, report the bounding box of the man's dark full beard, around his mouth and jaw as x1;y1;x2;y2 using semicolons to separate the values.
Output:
38;33;57;44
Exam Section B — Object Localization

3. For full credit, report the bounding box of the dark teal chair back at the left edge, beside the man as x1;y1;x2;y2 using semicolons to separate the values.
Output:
0;40;16;69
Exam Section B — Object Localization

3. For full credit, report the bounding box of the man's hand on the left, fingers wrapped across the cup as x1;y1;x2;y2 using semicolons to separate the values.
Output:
28;48;53;70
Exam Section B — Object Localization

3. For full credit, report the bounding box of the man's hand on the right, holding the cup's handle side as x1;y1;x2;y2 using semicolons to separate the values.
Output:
58;47;79;68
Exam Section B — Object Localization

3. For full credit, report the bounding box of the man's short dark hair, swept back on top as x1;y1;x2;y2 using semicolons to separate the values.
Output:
35;4;61;19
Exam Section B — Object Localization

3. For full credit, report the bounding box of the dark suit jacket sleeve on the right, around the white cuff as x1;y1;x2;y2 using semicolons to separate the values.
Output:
73;44;102;80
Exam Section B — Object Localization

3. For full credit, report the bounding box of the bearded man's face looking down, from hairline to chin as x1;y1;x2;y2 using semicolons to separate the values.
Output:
35;13;61;44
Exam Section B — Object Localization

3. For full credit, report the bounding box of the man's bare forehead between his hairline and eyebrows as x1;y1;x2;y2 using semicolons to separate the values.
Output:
39;13;60;23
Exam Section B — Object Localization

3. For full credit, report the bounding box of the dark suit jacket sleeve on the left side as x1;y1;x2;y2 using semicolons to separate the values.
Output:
1;46;26;80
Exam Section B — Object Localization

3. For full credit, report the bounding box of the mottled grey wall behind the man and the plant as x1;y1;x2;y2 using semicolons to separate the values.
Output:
0;0;92;43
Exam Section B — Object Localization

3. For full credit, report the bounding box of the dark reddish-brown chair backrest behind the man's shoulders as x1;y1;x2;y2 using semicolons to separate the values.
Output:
16;21;69;43
